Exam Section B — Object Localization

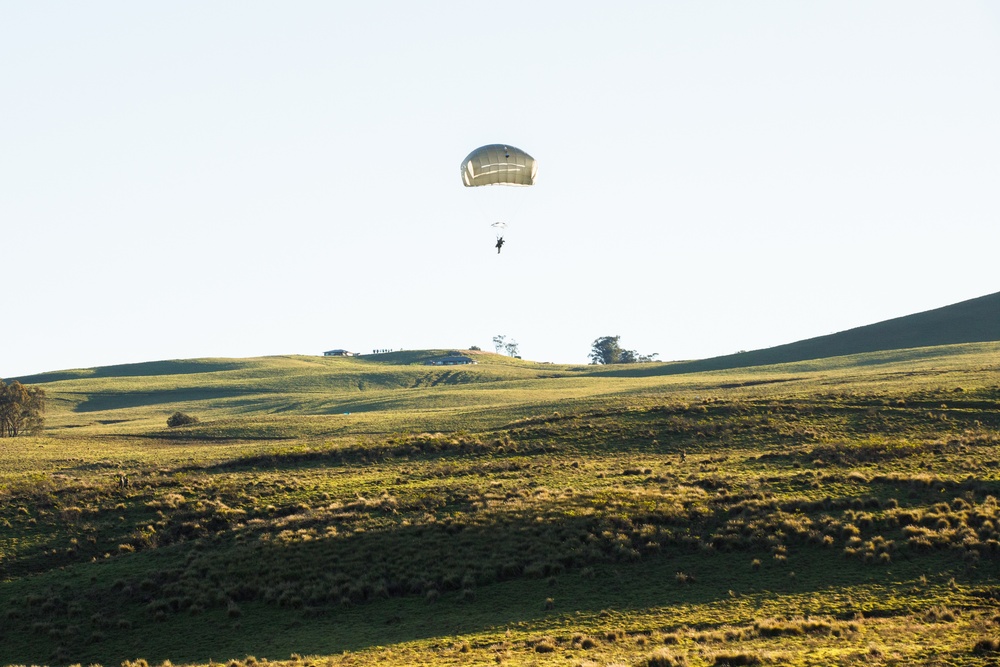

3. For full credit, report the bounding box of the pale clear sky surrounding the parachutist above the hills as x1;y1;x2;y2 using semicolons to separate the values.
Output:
0;0;1000;378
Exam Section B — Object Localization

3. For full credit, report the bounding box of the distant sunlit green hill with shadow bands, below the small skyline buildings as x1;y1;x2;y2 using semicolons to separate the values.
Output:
9;350;592;437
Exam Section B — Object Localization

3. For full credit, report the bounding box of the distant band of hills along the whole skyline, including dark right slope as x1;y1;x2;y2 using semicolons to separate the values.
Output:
11;293;1000;437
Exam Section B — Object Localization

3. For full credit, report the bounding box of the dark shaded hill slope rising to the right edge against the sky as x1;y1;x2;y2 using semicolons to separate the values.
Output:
596;292;1000;375
